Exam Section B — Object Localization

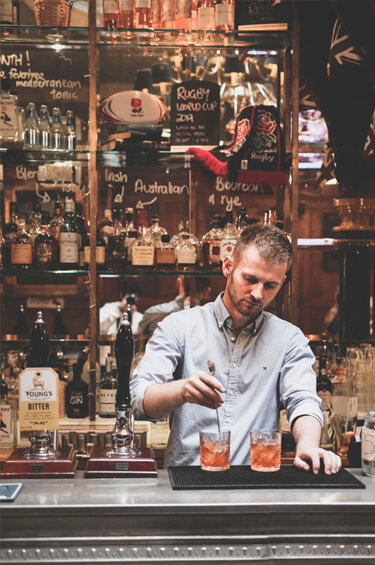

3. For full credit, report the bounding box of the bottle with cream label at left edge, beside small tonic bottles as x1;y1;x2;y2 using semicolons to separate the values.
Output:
0;77;20;146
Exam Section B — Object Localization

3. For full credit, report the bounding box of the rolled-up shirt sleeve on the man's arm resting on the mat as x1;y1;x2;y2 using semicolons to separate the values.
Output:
279;327;323;428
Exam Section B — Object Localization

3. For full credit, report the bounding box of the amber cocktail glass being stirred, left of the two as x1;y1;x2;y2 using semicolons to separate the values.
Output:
199;432;230;471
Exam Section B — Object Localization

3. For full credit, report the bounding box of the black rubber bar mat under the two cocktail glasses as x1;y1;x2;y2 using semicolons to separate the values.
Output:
168;465;366;490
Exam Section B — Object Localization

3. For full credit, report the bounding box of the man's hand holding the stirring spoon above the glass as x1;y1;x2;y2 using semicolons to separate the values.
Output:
181;371;225;409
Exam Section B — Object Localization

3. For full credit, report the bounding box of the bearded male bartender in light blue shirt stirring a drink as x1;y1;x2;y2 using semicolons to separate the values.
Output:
131;224;341;474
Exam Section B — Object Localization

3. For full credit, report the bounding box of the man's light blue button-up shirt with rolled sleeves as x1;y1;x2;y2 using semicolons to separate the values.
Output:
130;294;322;466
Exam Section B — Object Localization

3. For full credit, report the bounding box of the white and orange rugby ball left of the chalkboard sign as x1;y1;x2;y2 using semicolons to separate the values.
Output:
99;90;166;125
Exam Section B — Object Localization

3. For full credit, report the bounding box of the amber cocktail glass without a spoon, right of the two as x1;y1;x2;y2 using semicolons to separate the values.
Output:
250;430;281;472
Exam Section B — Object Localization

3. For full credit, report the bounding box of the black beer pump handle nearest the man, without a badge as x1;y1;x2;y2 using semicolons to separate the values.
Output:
115;312;134;408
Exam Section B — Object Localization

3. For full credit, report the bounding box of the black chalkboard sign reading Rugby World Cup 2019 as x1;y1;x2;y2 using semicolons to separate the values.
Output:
171;80;220;146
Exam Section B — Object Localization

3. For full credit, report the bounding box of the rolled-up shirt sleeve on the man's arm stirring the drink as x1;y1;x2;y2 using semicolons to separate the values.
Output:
130;312;183;420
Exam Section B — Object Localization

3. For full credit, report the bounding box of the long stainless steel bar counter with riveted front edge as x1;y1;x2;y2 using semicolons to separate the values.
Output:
1;469;375;565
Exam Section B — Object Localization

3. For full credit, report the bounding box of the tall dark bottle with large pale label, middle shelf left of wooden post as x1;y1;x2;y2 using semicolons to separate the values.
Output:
60;198;80;270
